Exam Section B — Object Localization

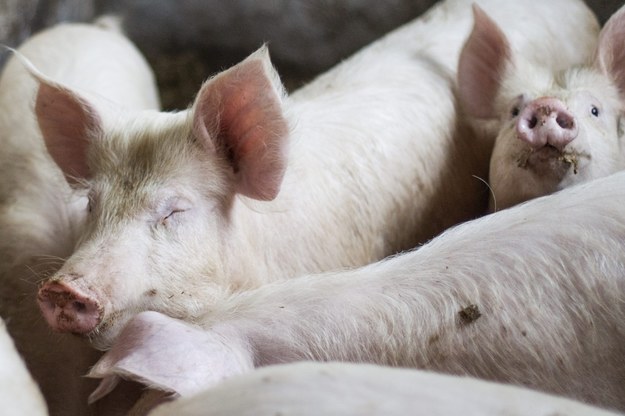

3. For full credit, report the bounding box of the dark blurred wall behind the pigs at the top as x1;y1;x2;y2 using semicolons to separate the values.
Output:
0;0;623;109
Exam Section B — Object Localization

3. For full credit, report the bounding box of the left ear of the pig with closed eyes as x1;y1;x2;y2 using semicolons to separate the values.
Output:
35;77;102;183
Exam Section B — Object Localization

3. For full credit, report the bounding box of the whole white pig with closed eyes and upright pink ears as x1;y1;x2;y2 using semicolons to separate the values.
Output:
36;0;598;350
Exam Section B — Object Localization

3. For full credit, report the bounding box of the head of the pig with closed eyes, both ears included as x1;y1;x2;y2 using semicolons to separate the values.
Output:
36;48;288;348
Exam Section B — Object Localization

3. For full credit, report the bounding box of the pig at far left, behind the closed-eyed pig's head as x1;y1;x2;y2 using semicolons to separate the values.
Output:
0;17;160;416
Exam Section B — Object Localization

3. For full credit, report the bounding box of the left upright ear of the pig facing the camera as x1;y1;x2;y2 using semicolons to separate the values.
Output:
458;4;511;118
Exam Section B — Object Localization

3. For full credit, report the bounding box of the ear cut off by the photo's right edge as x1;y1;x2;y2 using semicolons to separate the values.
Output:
595;6;625;96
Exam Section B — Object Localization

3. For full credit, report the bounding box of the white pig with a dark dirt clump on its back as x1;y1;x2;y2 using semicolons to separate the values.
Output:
89;172;625;411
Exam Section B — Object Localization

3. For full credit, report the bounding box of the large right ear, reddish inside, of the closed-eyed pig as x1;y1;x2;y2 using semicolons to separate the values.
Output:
193;47;288;200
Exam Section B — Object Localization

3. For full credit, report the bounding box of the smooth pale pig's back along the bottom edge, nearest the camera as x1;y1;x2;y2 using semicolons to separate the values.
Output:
149;362;619;416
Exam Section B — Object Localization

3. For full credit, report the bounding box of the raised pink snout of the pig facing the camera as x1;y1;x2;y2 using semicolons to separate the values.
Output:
516;98;577;150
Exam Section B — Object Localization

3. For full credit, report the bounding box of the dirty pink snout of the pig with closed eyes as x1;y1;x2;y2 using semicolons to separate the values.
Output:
37;282;102;334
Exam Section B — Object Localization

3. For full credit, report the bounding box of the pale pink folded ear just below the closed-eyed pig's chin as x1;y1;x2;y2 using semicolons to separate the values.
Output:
88;312;254;403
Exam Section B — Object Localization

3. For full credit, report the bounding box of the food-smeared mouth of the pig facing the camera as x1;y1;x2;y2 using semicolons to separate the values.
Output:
516;145;590;177
